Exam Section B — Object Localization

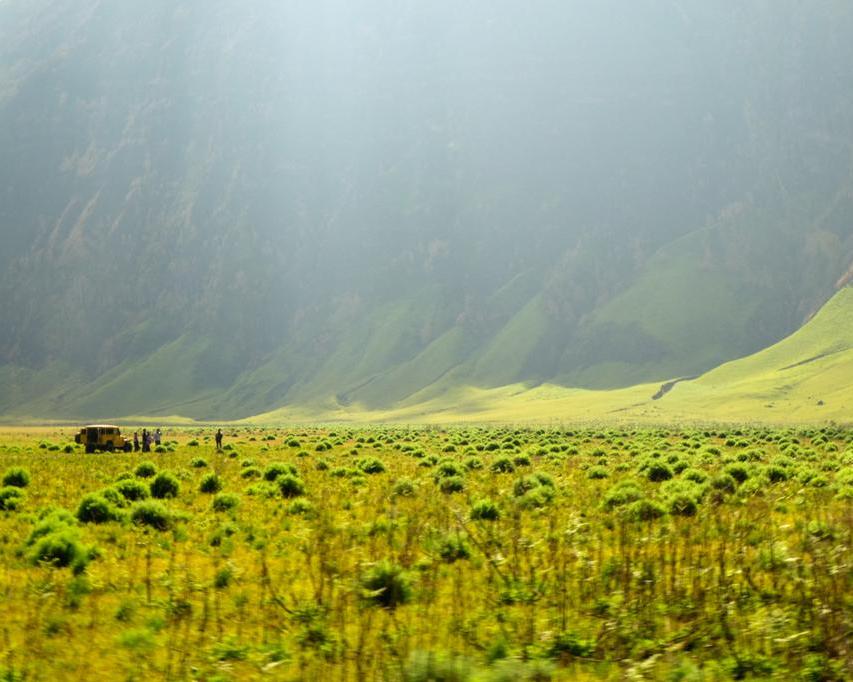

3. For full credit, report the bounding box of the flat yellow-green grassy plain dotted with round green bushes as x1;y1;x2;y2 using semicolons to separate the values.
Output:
0;426;853;681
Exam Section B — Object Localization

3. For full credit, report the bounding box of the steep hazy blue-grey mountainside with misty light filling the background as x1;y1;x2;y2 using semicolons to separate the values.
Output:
0;0;853;418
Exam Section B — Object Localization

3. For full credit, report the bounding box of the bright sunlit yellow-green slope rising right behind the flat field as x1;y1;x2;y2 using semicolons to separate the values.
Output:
251;287;853;424
